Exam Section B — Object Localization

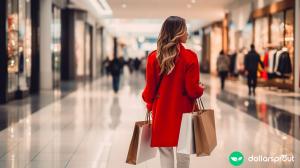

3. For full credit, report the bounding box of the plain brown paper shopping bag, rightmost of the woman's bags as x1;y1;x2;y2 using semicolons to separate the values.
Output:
193;99;217;156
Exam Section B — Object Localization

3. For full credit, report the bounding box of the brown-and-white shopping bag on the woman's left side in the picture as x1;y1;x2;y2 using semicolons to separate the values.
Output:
126;113;157;165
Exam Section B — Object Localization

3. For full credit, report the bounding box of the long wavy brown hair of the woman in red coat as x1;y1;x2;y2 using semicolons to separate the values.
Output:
157;16;186;74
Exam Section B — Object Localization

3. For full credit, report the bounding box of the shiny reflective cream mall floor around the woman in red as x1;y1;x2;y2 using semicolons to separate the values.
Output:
0;70;300;168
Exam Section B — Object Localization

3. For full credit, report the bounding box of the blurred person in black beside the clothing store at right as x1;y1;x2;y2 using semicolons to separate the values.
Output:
244;44;264;96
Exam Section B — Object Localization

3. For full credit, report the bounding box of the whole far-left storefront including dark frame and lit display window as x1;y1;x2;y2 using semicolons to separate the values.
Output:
0;0;32;103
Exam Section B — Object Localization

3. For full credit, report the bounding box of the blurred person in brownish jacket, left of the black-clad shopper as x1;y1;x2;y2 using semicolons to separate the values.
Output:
217;50;230;90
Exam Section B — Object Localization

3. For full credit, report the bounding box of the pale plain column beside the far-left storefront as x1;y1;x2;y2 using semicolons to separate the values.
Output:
39;0;53;90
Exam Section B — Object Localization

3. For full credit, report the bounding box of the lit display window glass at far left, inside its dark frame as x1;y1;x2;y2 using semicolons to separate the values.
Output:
6;0;31;93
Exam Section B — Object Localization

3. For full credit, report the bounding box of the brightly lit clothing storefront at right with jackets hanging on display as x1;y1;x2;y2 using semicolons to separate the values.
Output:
251;0;295;90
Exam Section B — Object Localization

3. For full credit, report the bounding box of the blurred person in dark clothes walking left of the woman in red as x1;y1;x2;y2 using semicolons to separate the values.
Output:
109;58;123;93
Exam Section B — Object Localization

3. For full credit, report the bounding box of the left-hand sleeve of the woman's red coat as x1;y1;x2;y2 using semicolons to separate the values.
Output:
142;54;157;111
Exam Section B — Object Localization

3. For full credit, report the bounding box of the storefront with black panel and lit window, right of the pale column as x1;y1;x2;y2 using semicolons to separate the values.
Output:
61;9;94;80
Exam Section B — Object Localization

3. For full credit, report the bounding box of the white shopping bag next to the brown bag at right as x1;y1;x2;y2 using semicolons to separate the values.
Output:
177;113;196;154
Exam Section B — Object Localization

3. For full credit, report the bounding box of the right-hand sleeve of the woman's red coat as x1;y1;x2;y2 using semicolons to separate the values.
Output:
184;54;203;99
